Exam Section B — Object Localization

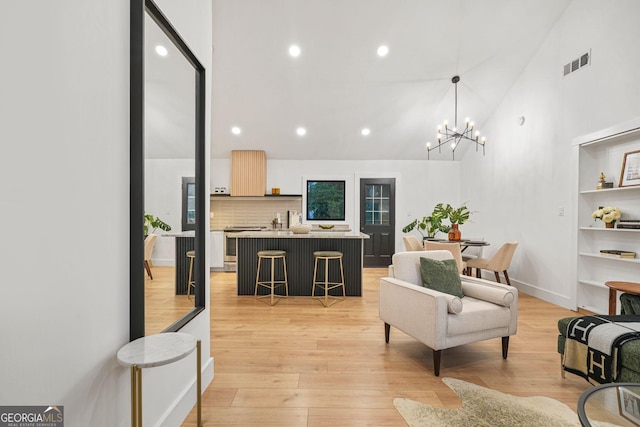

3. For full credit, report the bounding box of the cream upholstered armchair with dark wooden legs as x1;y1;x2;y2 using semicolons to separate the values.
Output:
379;251;518;376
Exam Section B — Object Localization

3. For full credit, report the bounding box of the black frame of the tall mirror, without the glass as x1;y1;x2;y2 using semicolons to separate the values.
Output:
129;0;207;341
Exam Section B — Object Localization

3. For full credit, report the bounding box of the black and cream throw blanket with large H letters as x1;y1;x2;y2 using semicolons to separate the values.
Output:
562;316;640;384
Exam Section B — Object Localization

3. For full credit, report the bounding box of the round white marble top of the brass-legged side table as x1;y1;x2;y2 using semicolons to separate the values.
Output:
118;332;196;368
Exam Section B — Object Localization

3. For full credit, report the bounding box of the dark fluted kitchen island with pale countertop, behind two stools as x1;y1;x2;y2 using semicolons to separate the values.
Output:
235;231;369;297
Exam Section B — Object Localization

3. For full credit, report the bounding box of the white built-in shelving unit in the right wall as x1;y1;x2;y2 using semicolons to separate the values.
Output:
574;119;640;314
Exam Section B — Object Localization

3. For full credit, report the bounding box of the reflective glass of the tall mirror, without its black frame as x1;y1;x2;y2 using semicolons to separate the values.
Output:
144;12;196;335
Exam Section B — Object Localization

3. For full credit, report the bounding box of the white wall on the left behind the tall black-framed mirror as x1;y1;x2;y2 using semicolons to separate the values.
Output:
0;0;212;427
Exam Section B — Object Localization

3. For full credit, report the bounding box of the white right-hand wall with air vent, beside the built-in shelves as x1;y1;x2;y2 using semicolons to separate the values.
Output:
461;0;640;308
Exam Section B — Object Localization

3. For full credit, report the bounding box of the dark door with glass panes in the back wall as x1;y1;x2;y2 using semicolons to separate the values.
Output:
360;178;396;267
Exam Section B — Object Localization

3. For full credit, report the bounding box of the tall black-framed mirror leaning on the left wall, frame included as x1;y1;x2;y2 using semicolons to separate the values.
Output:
130;0;206;340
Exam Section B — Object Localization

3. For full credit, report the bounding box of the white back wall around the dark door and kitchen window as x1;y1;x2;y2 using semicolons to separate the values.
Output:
211;158;460;251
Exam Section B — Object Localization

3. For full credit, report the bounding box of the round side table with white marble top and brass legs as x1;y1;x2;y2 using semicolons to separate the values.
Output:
118;332;202;427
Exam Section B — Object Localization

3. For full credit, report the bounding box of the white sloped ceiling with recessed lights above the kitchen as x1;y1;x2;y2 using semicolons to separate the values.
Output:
211;0;571;159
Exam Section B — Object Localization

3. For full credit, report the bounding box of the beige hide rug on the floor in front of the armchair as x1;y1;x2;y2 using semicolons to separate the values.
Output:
393;378;584;427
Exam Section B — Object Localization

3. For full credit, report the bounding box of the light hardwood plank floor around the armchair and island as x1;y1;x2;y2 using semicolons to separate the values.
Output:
183;269;589;427
